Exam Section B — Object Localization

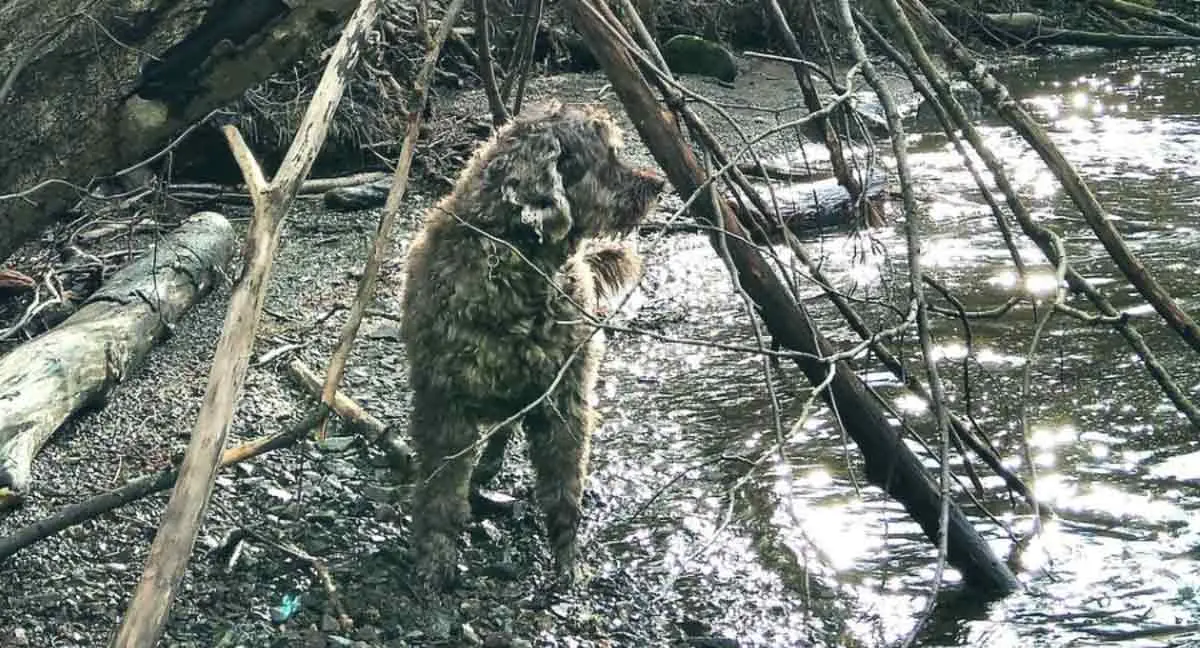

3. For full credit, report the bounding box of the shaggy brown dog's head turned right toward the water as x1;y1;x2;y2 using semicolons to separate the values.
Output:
480;102;664;245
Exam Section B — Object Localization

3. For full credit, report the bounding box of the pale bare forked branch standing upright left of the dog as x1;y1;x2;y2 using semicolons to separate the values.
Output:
110;0;378;648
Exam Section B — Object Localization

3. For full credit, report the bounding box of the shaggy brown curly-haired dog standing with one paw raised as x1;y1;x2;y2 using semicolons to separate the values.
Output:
401;103;664;588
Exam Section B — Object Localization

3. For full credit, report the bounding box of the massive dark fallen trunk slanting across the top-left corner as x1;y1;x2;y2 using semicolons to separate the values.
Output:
0;0;359;259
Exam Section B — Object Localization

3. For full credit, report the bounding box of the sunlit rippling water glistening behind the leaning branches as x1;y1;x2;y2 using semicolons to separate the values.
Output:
596;50;1200;647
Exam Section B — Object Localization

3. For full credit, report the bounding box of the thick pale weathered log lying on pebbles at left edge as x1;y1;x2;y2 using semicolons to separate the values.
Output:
0;212;235;492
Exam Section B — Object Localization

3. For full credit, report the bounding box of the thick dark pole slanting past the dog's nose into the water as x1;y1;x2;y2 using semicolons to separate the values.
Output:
564;0;1020;594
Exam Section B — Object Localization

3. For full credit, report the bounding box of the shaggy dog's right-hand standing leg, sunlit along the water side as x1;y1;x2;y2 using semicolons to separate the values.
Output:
524;359;596;584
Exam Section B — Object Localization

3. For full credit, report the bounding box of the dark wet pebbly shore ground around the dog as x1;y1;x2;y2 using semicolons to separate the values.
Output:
0;61;916;647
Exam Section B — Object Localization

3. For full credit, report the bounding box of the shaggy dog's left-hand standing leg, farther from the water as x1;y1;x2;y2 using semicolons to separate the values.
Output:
412;391;479;589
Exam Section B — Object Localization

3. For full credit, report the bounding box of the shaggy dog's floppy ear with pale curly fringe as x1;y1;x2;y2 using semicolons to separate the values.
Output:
502;131;575;242
